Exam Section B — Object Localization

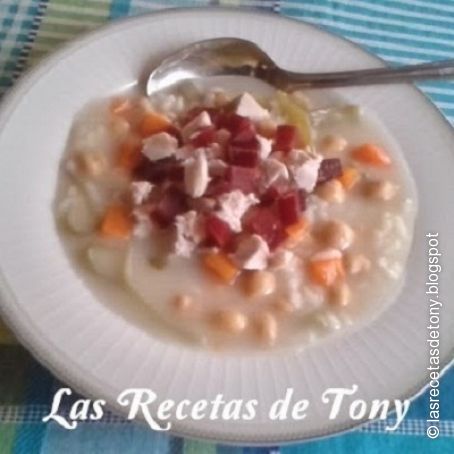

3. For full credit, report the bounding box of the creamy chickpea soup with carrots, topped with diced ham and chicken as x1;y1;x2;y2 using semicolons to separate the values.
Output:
55;83;416;349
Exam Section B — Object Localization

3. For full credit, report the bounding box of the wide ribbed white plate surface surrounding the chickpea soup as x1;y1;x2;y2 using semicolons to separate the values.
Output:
0;9;454;443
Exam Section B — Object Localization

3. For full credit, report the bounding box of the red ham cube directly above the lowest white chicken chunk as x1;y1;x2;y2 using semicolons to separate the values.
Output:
246;207;286;250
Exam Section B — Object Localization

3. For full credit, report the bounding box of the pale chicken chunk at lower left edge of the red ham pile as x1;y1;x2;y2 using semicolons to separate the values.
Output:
174;211;204;257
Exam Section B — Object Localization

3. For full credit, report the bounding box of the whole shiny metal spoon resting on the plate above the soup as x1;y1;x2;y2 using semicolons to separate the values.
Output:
146;38;454;95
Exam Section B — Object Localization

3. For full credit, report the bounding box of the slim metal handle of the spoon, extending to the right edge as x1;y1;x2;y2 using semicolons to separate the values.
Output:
281;59;454;91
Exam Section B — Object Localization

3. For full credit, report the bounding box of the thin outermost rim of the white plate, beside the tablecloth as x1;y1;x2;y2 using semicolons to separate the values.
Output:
0;6;454;446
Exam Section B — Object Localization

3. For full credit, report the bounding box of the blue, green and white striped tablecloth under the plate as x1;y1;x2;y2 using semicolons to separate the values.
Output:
0;0;454;454
